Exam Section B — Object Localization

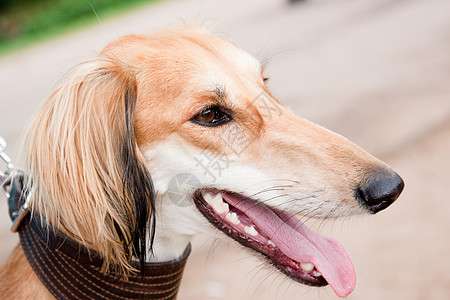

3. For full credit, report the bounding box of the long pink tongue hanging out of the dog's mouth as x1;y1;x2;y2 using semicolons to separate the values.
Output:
222;195;356;297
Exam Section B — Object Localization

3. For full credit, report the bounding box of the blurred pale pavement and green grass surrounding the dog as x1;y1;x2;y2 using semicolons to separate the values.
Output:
0;0;450;300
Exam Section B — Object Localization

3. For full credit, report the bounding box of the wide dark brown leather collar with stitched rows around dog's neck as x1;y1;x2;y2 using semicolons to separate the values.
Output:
9;176;191;300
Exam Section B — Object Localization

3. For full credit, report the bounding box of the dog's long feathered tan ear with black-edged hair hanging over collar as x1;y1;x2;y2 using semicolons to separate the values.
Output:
24;59;155;274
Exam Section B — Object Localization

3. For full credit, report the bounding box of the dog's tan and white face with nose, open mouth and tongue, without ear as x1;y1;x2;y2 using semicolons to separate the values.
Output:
100;31;403;296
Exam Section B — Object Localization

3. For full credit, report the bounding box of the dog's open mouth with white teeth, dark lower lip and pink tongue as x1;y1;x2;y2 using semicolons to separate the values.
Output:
194;189;356;297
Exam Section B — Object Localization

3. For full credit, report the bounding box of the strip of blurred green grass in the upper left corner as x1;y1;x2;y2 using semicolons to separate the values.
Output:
0;0;160;55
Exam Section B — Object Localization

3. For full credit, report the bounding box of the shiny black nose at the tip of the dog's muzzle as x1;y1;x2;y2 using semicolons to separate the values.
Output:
357;171;405;213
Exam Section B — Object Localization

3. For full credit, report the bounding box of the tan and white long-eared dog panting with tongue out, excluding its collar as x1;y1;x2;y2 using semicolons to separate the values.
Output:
0;27;404;299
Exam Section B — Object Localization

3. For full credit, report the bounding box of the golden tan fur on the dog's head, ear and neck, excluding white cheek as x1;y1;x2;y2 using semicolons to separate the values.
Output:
0;29;390;299
